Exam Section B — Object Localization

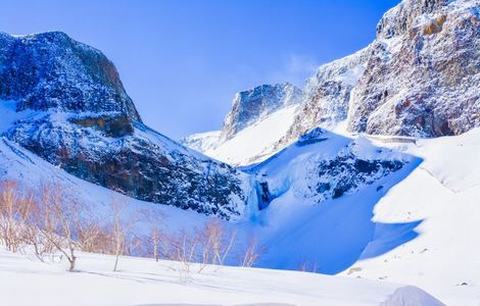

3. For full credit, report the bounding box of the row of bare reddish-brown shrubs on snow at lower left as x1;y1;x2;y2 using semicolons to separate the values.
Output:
0;181;262;279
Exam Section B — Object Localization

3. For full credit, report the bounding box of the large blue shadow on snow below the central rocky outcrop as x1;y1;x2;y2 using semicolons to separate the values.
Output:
251;130;423;274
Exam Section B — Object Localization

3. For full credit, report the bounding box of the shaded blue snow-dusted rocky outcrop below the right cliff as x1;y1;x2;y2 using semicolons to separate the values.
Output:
245;128;413;209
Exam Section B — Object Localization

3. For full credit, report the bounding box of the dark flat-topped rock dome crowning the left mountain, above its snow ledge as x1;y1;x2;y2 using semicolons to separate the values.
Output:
0;32;141;121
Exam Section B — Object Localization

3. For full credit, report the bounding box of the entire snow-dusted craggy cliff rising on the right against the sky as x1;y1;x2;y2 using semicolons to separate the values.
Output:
270;0;480;147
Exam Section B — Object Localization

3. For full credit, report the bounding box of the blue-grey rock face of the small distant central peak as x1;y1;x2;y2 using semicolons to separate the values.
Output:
220;83;302;141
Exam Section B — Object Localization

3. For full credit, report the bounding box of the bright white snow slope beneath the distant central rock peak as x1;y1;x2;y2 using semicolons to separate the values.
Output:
204;105;301;165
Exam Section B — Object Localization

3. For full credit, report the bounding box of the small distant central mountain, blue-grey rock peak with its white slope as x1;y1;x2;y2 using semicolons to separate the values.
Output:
180;83;303;161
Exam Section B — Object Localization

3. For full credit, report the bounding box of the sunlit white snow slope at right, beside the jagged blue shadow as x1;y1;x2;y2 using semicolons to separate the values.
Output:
345;129;480;305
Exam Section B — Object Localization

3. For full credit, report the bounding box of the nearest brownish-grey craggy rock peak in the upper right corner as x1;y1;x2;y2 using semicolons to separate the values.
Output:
349;0;480;137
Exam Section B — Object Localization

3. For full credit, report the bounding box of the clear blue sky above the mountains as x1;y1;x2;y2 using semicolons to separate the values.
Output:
0;0;399;138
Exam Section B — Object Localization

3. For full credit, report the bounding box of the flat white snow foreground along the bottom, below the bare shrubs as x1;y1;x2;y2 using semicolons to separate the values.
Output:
0;249;443;306
